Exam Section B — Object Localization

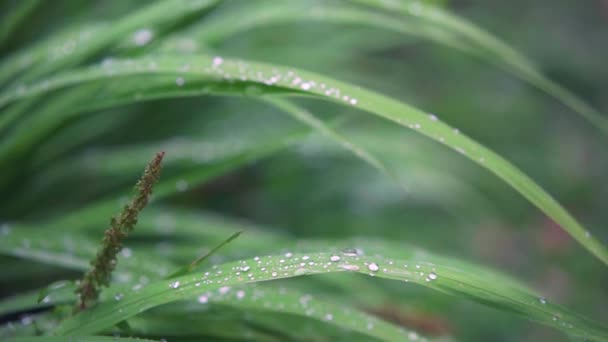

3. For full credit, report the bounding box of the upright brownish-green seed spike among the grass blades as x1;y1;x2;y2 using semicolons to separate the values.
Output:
76;152;165;310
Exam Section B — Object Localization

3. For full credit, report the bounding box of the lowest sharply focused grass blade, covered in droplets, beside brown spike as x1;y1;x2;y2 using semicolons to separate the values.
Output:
55;251;608;340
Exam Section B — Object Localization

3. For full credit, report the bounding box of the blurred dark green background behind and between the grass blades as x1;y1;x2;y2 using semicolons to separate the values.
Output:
0;0;608;341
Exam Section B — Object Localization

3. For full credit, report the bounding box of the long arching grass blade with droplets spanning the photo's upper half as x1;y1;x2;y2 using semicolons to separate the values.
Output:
0;55;608;264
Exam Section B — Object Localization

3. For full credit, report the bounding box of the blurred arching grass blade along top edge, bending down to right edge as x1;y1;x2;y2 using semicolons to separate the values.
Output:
194;0;608;134
